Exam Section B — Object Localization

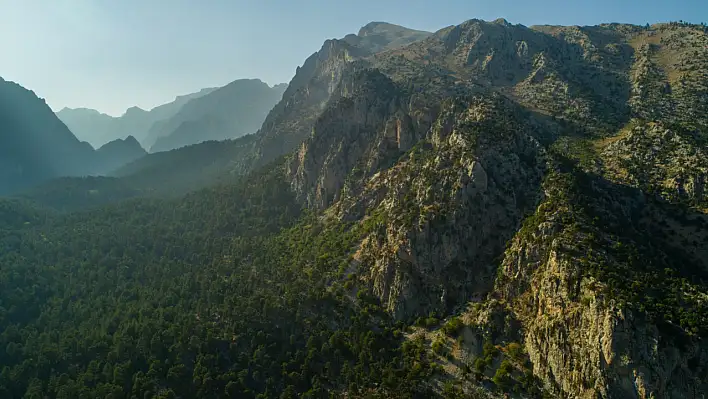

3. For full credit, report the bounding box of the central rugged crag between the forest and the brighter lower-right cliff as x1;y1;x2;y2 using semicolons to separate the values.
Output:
335;97;545;319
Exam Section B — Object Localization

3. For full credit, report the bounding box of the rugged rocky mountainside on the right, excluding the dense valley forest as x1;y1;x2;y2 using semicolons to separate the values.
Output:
254;20;708;398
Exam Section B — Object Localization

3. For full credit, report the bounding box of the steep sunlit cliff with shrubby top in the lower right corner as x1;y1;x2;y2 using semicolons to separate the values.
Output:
486;164;708;398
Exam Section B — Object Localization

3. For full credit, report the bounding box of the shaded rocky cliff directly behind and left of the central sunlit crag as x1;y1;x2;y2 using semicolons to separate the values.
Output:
290;71;414;209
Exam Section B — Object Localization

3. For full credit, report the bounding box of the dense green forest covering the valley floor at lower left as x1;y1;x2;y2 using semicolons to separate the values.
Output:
0;163;430;398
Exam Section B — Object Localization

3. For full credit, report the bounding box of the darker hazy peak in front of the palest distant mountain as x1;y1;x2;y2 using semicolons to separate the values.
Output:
146;79;287;152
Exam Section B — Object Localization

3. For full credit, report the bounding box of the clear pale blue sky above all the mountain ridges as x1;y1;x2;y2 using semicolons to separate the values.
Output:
0;0;708;116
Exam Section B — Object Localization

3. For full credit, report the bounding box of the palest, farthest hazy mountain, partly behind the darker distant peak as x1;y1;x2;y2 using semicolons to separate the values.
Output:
57;88;216;148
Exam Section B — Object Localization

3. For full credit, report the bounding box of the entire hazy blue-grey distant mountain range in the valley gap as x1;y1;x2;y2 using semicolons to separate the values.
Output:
57;79;287;152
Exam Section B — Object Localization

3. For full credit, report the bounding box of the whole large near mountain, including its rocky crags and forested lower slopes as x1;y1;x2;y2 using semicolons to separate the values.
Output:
0;19;708;398
